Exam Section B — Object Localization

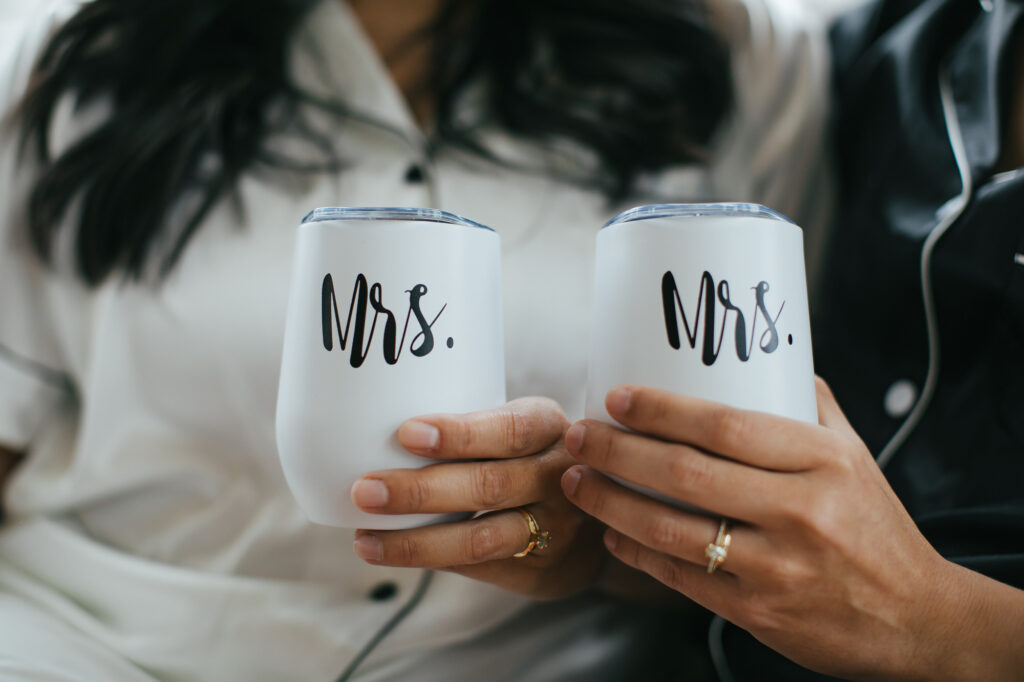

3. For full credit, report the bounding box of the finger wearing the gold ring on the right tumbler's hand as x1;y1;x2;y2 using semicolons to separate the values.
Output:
562;467;764;573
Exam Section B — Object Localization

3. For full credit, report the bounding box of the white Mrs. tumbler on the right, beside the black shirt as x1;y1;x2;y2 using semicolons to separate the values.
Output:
586;204;817;504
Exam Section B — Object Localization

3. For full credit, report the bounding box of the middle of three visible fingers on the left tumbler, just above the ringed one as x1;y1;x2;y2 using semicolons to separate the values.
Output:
350;447;572;514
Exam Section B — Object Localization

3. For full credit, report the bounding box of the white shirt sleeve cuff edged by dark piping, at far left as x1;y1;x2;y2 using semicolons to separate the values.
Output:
0;346;68;451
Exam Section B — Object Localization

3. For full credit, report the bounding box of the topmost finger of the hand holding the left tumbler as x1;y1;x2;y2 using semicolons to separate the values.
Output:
398;397;568;459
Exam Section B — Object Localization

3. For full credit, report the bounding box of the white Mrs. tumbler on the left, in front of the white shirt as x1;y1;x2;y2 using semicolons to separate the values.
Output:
276;208;505;529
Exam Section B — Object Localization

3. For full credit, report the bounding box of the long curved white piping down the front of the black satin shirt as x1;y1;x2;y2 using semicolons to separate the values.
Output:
878;61;974;467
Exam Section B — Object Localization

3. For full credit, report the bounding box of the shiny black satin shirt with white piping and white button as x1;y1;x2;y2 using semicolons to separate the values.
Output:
723;0;1024;680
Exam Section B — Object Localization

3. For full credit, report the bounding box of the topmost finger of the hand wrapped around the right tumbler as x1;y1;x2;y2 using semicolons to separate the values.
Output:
605;386;835;471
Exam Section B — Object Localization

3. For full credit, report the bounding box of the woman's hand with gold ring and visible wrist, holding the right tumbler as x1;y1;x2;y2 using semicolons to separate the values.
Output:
562;380;1024;680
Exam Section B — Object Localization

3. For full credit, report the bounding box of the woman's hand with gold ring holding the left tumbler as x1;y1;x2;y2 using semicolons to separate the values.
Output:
351;397;607;599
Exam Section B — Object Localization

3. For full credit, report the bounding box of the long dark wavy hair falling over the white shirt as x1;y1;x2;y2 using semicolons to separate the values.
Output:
18;0;732;285
